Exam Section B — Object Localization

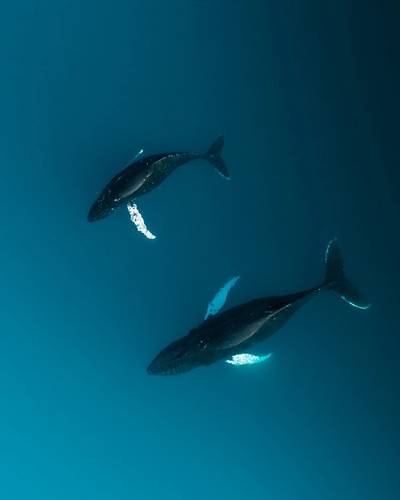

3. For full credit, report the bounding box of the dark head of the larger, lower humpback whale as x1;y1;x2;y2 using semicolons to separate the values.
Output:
147;335;207;375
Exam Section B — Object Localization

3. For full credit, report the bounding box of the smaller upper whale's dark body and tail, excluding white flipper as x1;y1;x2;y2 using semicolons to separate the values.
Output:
87;136;230;222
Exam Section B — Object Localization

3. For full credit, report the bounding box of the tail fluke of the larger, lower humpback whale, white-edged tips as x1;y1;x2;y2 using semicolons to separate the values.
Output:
325;240;371;309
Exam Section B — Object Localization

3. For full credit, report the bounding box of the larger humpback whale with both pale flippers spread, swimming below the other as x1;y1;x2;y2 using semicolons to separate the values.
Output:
147;240;370;375
